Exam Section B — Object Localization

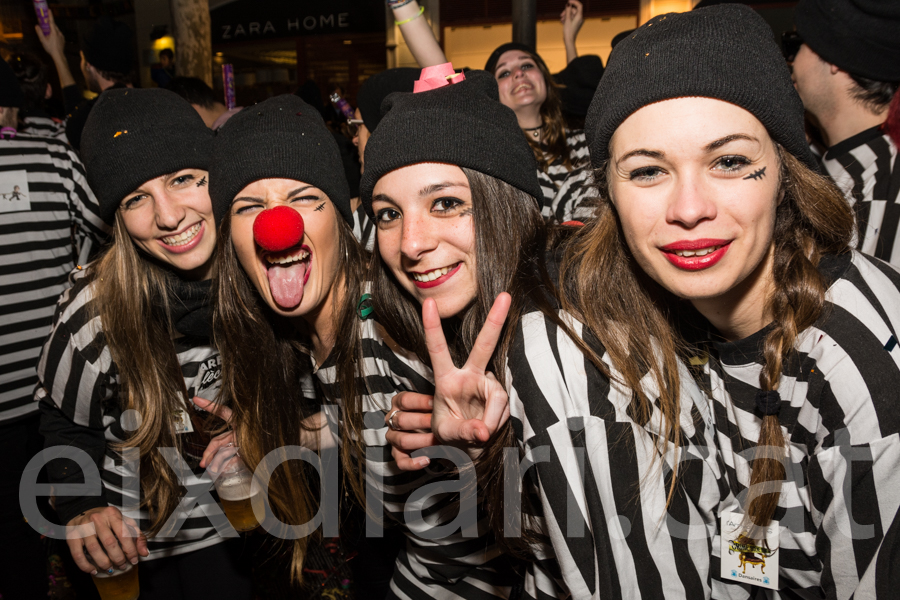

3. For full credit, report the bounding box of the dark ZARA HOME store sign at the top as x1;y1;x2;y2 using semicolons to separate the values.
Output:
210;0;385;44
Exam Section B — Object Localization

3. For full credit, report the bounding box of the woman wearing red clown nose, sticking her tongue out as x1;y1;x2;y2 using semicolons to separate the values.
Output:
208;96;521;600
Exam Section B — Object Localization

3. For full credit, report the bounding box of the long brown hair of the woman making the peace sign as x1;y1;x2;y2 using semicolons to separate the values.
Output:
372;168;568;557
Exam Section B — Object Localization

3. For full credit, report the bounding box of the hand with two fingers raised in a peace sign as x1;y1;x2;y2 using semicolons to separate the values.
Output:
422;292;511;453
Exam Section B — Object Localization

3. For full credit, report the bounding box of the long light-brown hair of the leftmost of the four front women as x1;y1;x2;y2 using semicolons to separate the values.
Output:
88;212;187;537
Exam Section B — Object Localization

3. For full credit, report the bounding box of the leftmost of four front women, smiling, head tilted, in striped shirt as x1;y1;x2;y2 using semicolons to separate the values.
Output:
36;89;252;600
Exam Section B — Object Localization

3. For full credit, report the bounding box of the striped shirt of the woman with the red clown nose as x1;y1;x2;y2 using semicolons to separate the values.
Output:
316;319;517;600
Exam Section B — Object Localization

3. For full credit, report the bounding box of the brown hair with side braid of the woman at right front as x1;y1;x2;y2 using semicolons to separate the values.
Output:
576;144;853;539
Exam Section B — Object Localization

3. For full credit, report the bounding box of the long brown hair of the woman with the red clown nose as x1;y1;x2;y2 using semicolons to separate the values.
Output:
213;211;366;582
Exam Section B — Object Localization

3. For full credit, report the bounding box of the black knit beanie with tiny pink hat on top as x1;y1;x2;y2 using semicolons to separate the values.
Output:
359;71;543;217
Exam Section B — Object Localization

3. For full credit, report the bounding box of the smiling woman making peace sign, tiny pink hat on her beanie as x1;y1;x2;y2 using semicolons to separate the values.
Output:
361;71;720;598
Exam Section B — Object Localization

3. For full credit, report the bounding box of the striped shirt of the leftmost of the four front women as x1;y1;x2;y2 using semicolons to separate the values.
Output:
35;267;232;560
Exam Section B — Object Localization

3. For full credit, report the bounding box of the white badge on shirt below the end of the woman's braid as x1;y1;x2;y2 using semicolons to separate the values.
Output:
720;512;781;590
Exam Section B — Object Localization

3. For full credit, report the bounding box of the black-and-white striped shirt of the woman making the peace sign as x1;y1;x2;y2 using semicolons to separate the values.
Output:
507;311;729;600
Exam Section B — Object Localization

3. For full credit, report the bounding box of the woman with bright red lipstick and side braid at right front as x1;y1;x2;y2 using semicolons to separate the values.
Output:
563;5;900;598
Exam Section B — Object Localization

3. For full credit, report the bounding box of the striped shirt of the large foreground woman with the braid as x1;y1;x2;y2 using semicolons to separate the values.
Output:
705;251;900;599
